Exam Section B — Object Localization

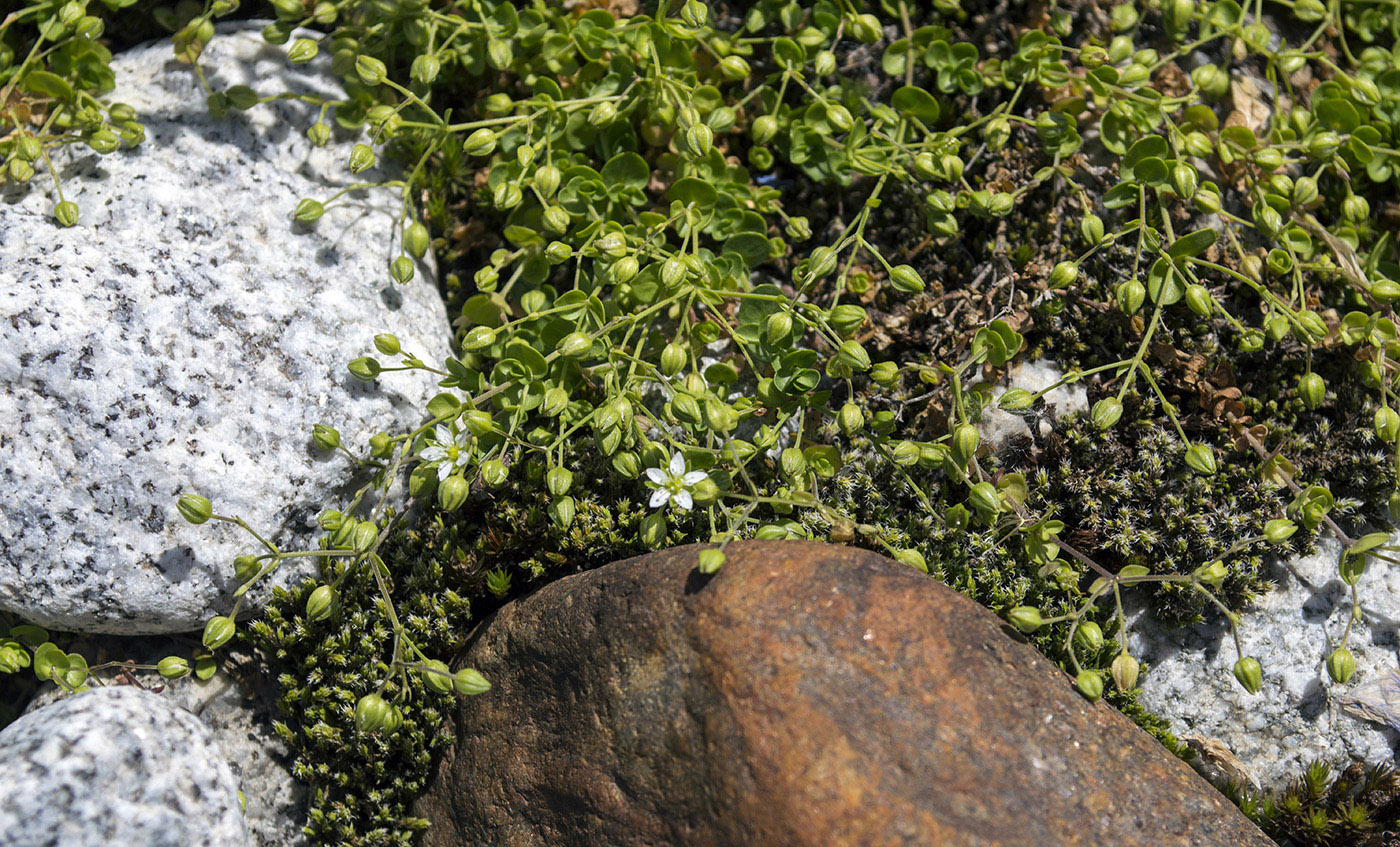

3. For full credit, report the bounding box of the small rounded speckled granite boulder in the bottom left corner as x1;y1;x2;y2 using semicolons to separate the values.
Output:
0;686;249;847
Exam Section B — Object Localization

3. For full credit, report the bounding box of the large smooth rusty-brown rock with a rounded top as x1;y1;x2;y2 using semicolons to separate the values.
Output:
419;542;1273;847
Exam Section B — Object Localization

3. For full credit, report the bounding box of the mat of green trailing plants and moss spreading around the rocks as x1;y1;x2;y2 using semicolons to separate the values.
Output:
0;0;1400;843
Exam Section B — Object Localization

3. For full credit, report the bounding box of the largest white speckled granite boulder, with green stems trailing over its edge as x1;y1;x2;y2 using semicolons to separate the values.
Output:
0;22;451;634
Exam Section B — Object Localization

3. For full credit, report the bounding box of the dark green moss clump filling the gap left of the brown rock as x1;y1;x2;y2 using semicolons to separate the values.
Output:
248;528;469;847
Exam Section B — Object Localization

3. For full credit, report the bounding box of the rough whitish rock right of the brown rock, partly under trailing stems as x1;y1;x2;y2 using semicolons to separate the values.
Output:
1130;538;1400;788
